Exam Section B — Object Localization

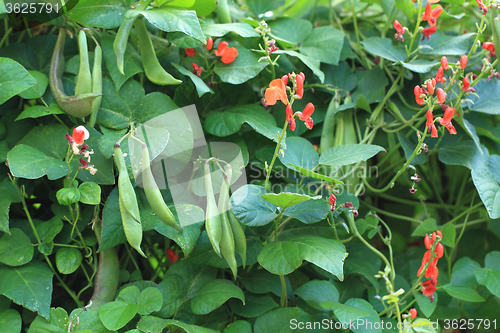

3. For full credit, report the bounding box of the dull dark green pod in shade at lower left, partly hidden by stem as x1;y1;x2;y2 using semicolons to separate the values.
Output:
89;222;120;311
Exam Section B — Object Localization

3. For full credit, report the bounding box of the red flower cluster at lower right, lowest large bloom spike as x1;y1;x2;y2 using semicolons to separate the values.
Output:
417;230;444;303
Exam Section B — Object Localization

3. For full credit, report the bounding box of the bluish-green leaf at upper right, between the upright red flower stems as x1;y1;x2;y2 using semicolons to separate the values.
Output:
420;29;475;56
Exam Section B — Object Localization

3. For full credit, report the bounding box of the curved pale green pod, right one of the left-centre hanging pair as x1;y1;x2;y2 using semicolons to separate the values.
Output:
142;144;182;232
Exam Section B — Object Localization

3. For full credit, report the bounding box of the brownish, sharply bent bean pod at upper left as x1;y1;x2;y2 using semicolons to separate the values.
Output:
49;29;102;118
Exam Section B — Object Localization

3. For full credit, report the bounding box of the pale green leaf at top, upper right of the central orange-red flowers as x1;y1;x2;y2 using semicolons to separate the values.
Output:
300;26;344;65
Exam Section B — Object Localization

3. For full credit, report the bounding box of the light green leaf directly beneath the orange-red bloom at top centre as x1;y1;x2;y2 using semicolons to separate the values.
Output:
214;46;268;84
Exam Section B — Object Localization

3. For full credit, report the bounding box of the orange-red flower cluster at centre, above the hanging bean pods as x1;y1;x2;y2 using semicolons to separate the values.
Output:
263;72;314;131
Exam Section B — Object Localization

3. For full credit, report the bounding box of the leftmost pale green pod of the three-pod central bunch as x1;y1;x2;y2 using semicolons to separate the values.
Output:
204;161;222;257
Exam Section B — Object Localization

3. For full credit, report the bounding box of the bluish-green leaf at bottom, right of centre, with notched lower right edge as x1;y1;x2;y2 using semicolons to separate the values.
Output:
295;280;339;311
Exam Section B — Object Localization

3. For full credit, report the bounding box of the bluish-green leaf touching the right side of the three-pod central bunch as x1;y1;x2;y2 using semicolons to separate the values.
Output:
231;185;278;226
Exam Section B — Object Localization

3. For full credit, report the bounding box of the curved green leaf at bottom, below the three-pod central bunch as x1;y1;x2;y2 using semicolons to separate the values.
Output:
191;280;245;315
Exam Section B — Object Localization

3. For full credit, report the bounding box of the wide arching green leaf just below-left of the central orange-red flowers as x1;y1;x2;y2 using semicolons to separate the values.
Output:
205;104;281;142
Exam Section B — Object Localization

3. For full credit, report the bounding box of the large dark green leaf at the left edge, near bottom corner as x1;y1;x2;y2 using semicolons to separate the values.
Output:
0;261;54;319
